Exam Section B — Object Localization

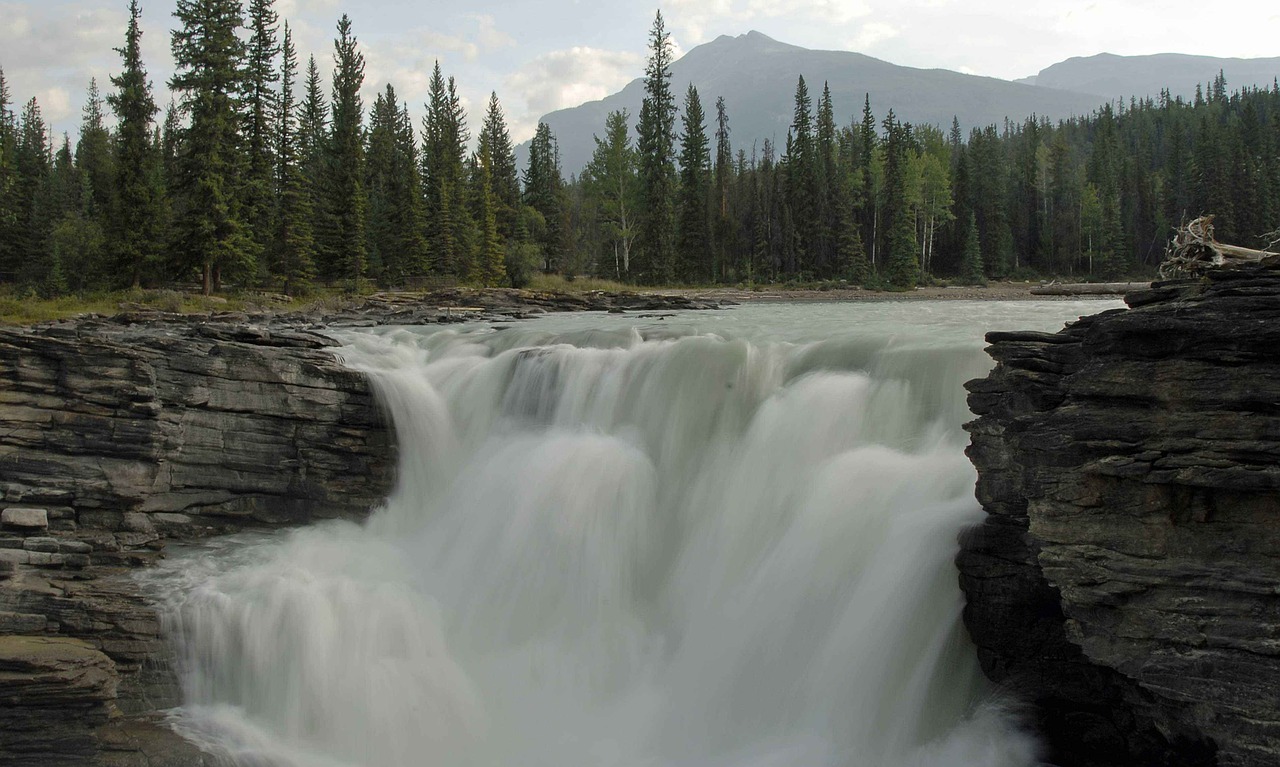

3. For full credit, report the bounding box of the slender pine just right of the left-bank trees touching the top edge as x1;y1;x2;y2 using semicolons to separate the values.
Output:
271;23;315;296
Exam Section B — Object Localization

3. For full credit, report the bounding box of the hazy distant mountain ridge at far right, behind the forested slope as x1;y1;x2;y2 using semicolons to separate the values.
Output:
1018;54;1280;99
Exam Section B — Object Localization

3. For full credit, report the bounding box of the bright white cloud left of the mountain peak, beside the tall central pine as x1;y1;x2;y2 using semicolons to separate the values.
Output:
504;47;645;142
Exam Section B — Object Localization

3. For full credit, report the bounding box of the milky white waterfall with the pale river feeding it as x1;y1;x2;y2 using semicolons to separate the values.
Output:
154;302;1110;767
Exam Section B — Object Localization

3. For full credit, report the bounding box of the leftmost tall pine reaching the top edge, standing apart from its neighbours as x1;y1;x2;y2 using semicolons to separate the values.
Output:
108;0;163;287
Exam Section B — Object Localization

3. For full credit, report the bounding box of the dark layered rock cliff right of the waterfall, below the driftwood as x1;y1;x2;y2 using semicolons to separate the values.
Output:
957;269;1280;767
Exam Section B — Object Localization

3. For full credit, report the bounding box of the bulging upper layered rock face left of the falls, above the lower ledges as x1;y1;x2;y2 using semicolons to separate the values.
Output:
0;321;393;533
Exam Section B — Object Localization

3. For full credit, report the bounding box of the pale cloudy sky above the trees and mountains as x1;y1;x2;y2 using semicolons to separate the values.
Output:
0;0;1280;142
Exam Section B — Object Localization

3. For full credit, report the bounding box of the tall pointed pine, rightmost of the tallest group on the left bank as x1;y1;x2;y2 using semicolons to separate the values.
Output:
323;14;369;289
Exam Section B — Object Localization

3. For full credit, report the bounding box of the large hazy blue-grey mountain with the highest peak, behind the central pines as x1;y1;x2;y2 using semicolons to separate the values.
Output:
521;32;1101;175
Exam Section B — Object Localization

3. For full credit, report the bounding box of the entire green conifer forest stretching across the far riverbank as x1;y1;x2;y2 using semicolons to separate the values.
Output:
0;7;1280;296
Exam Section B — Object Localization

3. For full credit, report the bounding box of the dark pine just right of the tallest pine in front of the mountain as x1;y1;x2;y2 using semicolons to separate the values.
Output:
676;85;712;283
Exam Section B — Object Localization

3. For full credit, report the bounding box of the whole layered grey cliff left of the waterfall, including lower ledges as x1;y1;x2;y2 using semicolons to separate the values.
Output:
0;316;394;767
